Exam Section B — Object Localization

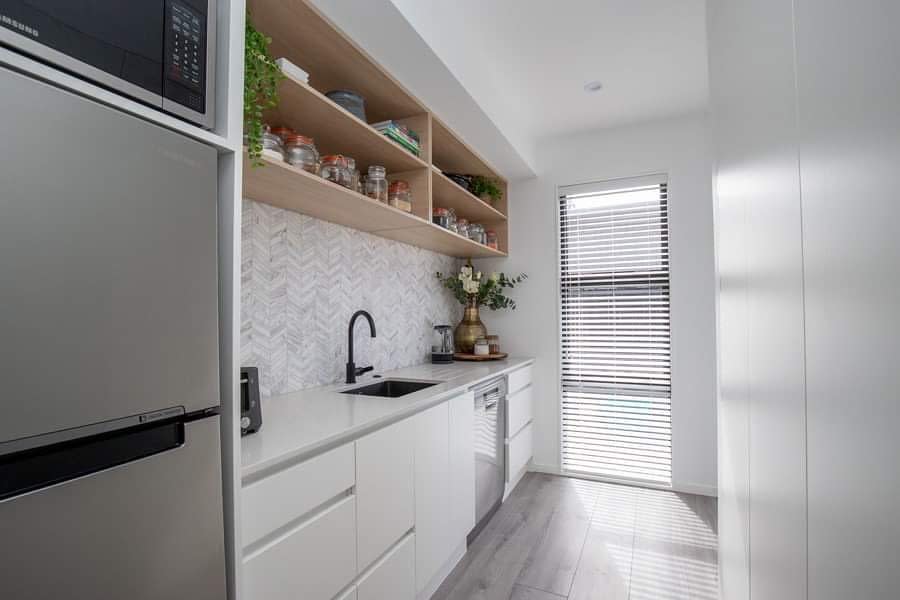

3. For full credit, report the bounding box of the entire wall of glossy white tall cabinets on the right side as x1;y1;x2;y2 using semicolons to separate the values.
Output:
707;0;900;600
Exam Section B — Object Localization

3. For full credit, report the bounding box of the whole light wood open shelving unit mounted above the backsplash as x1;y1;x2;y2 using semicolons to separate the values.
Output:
243;0;509;258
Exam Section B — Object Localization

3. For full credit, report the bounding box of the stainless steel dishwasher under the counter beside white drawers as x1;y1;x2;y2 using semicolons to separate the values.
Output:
468;375;506;543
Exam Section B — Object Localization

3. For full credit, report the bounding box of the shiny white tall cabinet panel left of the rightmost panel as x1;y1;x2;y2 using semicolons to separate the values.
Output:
708;0;806;600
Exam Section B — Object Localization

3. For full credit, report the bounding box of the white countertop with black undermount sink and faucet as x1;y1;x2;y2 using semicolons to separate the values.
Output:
241;357;534;483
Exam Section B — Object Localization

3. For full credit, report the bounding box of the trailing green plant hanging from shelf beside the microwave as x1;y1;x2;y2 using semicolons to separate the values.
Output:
244;12;284;167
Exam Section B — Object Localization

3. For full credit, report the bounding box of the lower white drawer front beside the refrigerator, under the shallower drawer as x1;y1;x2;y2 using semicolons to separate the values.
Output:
244;496;356;600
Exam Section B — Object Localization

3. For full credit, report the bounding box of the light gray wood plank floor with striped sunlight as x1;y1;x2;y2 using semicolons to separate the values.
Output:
432;473;718;600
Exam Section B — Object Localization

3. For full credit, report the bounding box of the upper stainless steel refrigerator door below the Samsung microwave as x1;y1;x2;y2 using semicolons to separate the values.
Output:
0;68;219;444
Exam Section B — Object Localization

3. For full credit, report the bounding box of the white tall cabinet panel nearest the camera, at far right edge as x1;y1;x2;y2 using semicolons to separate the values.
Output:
796;0;900;600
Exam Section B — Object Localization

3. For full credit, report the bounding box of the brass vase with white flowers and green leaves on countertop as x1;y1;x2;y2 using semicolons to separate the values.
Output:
437;261;528;354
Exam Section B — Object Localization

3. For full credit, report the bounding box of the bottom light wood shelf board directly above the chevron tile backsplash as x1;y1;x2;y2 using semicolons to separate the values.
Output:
243;153;506;258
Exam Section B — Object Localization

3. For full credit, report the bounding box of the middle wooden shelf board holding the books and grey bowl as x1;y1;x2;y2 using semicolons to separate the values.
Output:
265;77;428;173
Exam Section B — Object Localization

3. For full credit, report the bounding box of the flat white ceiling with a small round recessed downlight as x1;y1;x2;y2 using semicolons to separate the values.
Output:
392;0;708;142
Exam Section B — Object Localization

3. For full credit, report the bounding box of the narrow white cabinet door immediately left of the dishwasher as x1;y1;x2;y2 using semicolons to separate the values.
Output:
449;392;475;536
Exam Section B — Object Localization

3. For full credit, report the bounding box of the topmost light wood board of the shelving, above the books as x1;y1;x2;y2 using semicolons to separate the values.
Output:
247;0;427;123
